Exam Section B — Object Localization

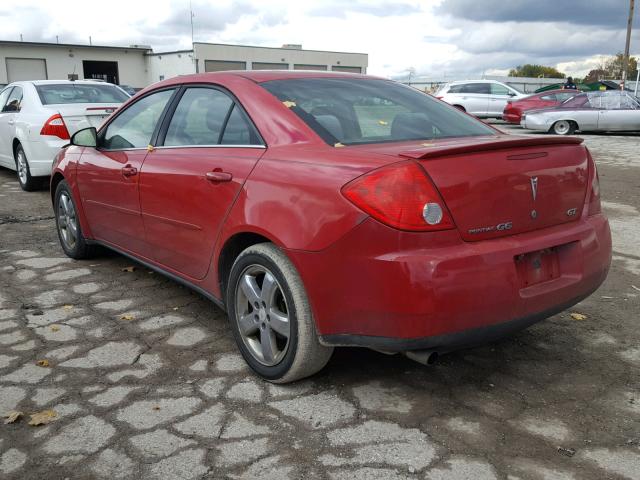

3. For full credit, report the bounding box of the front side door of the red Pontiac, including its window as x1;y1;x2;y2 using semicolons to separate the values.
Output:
77;88;176;256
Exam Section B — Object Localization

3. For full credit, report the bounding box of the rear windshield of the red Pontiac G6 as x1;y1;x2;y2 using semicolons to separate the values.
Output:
260;78;496;145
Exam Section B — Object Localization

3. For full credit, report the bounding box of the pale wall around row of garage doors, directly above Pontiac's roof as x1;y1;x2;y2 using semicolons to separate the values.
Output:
193;43;368;73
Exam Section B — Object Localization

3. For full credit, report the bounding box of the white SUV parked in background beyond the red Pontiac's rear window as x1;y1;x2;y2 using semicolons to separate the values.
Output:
435;80;528;119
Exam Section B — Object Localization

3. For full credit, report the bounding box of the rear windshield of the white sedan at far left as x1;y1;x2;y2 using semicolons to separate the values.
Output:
36;83;129;105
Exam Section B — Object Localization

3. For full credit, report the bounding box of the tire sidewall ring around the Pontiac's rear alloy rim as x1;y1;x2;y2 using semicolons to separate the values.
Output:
226;252;299;380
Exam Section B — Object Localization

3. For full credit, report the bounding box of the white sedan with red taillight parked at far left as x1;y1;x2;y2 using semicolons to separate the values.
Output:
0;80;129;191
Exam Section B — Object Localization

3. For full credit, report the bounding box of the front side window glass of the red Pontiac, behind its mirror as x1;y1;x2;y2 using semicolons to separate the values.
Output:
100;89;174;150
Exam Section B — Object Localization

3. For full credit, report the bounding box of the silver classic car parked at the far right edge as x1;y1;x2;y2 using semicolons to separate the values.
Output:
520;90;640;135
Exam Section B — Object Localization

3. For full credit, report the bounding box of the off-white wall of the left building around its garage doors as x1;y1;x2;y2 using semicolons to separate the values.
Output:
0;43;149;87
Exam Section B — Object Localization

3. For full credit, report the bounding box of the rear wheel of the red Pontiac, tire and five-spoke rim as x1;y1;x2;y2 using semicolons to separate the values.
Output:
226;243;333;383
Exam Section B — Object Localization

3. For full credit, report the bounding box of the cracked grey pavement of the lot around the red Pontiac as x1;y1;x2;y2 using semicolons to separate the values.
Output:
0;127;640;480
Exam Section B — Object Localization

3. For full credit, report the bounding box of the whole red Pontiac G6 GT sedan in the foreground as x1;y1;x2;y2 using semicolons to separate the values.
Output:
51;71;611;383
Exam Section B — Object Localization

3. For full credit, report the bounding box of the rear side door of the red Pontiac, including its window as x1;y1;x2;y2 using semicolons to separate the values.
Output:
140;86;265;279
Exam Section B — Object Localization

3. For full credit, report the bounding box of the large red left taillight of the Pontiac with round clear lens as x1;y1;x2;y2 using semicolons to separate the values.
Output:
342;162;455;232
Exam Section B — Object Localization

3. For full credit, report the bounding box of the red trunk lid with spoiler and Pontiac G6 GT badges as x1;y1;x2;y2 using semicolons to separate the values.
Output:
352;135;589;241
